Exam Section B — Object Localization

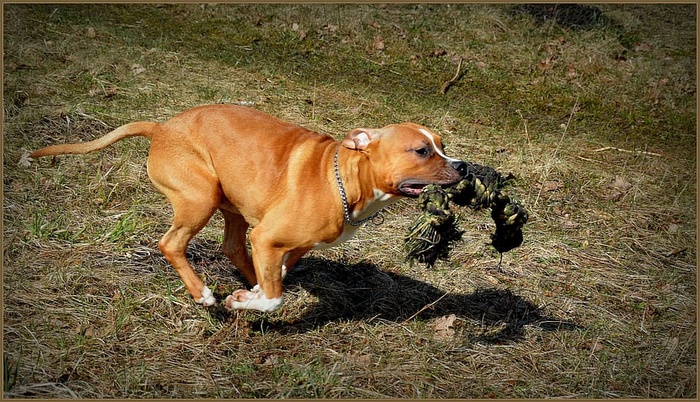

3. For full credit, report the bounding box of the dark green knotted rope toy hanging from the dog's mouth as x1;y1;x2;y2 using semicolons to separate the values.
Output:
404;163;528;266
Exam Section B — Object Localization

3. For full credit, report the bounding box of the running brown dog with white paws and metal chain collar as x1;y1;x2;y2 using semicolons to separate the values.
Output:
29;105;466;311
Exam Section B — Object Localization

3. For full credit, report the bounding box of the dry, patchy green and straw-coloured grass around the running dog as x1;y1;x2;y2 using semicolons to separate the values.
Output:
3;4;697;398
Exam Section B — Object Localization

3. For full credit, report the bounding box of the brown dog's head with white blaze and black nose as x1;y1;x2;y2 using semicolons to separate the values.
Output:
342;123;467;197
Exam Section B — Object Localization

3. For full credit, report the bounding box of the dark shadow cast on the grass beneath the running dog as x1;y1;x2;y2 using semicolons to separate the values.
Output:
232;257;581;344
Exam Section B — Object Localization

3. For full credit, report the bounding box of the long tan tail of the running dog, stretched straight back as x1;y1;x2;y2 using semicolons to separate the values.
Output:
27;121;160;158
